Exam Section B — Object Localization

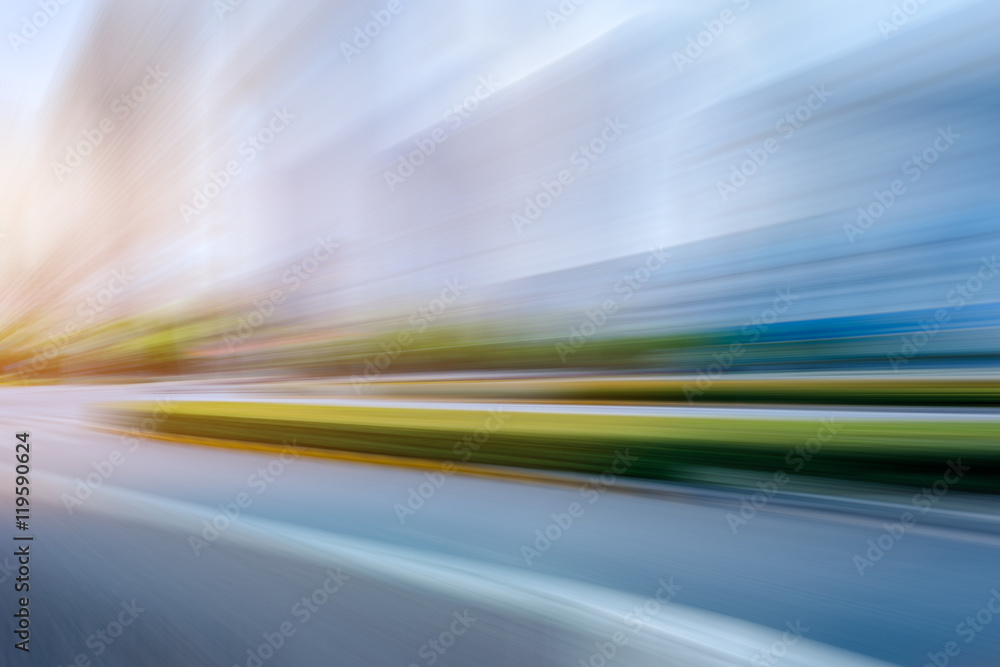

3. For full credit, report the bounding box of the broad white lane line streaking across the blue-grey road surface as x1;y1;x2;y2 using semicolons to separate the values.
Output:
34;472;904;667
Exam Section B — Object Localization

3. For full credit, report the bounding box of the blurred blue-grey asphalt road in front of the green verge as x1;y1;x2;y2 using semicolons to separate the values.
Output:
0;384;1000;667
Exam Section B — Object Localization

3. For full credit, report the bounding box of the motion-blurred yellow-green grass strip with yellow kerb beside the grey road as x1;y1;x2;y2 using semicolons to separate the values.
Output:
106;402;1000;493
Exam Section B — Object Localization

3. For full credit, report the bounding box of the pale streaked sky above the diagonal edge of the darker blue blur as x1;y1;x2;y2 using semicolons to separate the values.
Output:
0;0;995;336
